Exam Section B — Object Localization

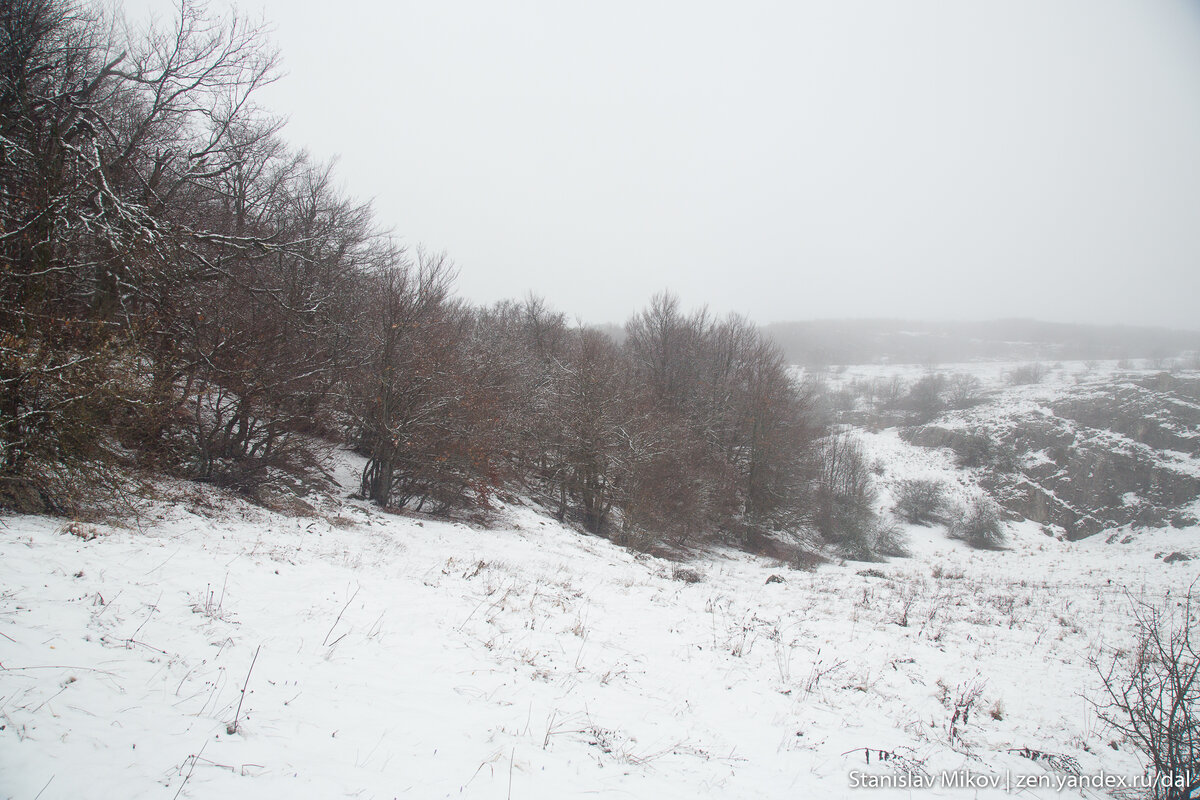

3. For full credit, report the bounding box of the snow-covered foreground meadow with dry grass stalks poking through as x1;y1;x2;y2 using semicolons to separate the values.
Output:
0;441;1200;799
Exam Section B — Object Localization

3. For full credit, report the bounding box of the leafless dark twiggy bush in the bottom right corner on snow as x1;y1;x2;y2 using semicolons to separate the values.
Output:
1093;589;1200;800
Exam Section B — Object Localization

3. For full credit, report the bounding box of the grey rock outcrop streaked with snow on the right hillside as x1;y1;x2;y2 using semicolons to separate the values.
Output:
902;374;1200;539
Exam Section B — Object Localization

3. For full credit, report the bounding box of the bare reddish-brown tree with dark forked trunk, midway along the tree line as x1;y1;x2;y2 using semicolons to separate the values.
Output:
352;252;503;512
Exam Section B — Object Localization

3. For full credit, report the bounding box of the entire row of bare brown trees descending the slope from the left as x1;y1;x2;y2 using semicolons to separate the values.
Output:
0;0;844;551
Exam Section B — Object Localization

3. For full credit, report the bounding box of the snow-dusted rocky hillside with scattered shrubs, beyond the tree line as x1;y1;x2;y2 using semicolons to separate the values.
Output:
811;362;1200;539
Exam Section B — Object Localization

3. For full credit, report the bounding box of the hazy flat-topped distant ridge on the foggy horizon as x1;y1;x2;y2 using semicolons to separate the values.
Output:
764;319;1200;365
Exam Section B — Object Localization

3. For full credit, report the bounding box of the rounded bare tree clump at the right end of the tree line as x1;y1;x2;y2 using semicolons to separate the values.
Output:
625;294;816;544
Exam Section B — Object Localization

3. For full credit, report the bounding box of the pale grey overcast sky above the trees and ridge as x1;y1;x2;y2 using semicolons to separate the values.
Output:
125;0;1200;329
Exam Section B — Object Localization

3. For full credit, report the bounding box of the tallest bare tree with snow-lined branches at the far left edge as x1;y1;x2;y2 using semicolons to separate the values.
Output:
0;0;274;505
